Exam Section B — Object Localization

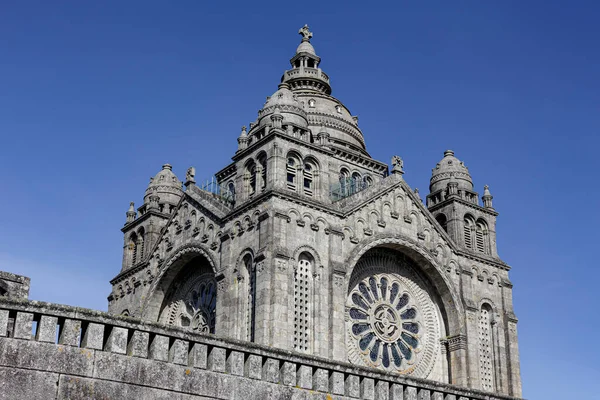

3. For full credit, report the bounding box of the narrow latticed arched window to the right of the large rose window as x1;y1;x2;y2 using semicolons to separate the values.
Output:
477;304;495;391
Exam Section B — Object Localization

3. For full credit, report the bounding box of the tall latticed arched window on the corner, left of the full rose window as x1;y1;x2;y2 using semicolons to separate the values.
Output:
294;252;314;353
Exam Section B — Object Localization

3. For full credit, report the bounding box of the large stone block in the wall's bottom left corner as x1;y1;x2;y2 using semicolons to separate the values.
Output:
0;367;59;400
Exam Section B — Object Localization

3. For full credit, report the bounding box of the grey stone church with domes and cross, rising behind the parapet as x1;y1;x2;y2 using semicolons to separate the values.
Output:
108;26;521;398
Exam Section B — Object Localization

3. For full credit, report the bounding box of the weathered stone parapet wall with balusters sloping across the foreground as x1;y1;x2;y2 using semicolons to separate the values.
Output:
0;299;514;400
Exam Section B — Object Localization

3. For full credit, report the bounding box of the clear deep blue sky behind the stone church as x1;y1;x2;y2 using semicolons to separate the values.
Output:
0;0;600;399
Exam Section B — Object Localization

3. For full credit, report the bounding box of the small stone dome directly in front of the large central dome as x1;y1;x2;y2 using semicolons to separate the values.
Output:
258;83;308;128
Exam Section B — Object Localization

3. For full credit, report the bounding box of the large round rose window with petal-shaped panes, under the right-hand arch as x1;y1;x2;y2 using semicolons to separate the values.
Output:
347;252;439;377
